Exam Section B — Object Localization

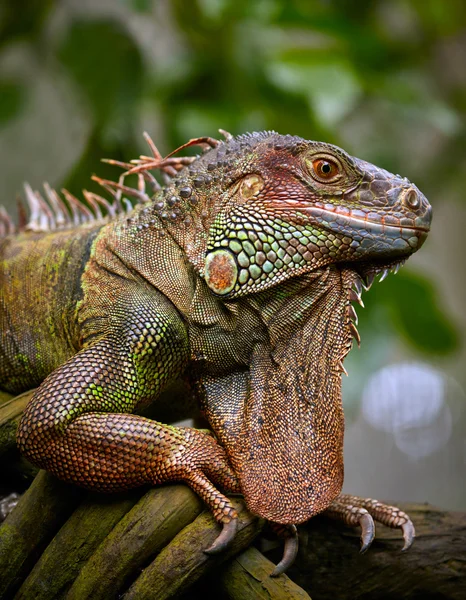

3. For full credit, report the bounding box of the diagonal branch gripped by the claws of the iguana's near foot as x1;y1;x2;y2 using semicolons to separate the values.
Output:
123;500;262;600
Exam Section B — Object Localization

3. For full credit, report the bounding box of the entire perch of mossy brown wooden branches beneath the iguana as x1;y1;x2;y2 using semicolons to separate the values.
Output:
0;395;466;600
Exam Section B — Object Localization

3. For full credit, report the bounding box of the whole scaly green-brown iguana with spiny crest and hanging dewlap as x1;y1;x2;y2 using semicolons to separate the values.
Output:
0;132;431;574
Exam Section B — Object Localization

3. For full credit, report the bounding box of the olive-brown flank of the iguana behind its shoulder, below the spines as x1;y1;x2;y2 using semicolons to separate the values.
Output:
0;225;101;393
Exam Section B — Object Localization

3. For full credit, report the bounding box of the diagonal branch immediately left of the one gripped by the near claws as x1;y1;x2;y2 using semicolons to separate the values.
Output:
66;485;203;600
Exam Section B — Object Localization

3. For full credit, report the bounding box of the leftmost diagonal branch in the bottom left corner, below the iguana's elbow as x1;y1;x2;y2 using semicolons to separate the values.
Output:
0;471;82;599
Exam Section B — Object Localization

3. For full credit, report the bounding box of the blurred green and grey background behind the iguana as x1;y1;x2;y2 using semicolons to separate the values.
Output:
0;0;466;507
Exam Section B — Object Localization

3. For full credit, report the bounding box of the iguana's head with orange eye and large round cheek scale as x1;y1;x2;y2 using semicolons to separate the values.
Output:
184;133;431;298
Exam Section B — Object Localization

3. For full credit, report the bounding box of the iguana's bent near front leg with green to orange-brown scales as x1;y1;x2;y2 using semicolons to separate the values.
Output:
18;293;238;551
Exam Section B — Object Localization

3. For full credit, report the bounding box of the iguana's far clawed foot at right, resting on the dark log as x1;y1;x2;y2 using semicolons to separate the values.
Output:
324;494;415;552
